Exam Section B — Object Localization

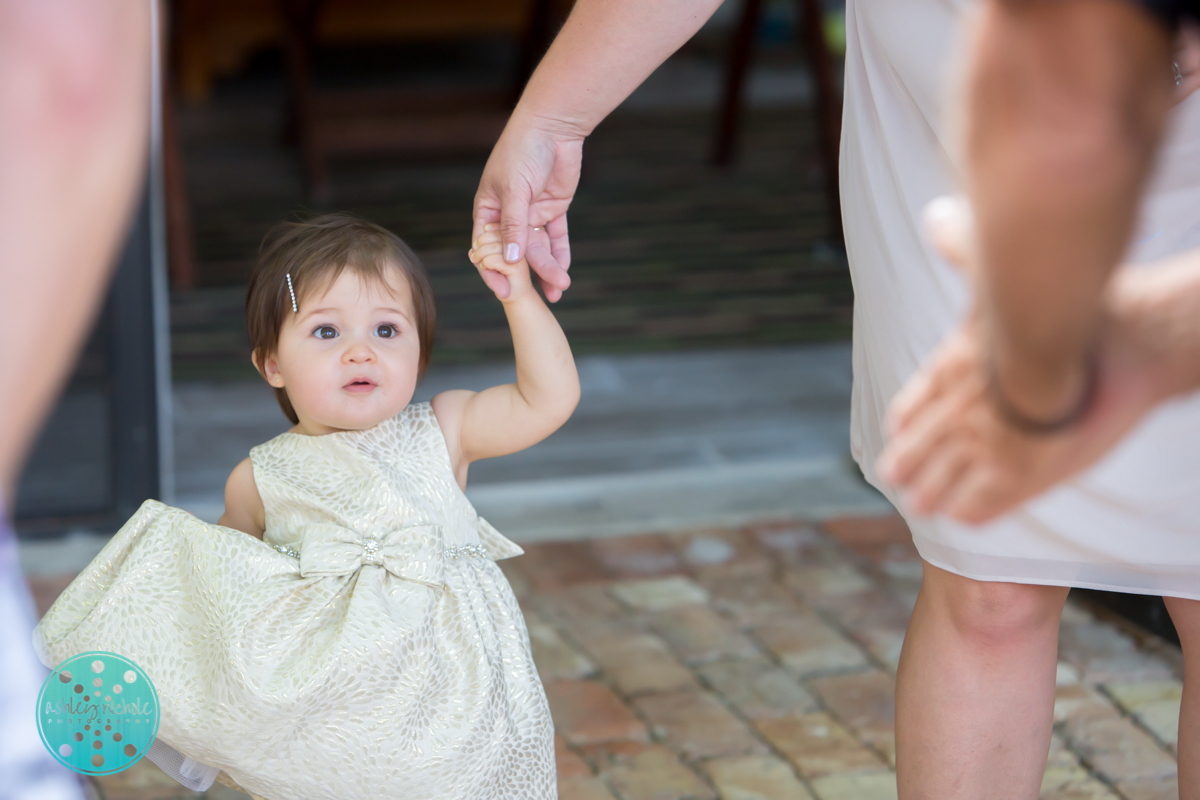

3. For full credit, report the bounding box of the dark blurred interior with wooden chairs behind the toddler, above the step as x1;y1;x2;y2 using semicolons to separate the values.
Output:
172;0;851;379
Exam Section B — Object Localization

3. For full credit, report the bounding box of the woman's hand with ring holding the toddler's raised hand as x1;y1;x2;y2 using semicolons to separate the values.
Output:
472;114;584;302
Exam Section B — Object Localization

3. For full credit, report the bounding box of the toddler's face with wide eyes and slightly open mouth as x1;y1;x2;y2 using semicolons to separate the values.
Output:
263;270;421;435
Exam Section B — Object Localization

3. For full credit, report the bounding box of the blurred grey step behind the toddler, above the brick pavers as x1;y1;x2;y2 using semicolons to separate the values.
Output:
14;342;892;575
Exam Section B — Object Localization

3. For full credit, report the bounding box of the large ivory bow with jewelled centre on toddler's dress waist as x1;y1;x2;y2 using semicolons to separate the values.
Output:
300;524;445;589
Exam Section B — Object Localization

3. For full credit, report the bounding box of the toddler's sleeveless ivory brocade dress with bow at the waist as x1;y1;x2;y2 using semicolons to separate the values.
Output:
34;403;557;800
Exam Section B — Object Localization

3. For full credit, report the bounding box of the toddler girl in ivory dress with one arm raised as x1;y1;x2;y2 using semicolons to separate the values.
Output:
35;215;580;800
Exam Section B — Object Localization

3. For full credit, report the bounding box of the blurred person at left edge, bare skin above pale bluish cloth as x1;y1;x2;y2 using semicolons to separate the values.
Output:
0;0;151;800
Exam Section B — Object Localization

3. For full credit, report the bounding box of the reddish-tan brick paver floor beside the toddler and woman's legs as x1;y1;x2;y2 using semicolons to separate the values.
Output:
28;517;1182;800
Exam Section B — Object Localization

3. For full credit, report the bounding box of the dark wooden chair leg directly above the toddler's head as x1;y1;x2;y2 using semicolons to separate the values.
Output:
280;0;329;201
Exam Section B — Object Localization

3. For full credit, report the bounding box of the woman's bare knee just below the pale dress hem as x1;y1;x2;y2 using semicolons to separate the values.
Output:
923;565;1067;648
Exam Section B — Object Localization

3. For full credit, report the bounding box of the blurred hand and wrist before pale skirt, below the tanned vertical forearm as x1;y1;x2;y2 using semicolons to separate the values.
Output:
877;196;1200;524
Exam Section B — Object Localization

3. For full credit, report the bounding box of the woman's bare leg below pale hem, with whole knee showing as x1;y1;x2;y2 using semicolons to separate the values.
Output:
896;564;1067;800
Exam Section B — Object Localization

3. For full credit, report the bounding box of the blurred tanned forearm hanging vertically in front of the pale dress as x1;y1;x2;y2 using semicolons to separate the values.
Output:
964;0;1171;419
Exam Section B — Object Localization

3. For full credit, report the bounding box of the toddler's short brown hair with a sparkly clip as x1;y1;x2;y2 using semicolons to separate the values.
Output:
246;213;437;423
